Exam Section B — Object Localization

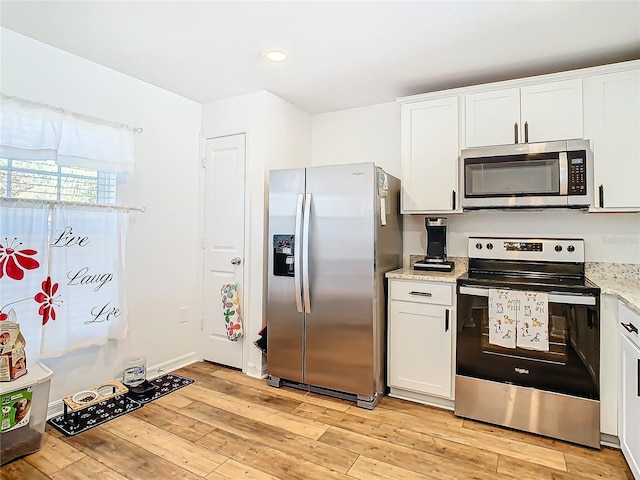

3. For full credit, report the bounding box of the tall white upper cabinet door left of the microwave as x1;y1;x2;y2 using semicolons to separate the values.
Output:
401;97;459;213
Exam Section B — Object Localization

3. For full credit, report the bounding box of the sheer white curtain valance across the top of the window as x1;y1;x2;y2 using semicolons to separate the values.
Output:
0;94;134;172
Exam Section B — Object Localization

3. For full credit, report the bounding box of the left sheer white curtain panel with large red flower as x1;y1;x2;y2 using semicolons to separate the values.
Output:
0;200;49;361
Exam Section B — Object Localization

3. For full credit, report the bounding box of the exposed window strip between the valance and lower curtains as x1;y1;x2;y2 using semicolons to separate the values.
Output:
0;158;116;205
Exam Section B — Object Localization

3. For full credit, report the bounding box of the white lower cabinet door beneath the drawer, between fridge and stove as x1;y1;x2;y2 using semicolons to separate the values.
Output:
389;302;453;398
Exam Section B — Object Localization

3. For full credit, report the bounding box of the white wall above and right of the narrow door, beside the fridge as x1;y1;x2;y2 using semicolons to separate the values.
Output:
200;91;311;377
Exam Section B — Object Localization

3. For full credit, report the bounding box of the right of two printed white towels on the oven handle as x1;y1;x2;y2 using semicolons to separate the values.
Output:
517;292;549;352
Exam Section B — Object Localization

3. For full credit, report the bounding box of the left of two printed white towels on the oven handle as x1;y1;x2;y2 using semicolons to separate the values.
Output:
489;288;518;348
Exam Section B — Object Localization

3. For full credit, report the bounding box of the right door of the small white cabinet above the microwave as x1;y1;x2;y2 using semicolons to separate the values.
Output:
520;78;583;142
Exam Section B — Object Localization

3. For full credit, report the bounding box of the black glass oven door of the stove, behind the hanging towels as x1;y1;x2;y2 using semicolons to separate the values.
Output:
456;283;600;400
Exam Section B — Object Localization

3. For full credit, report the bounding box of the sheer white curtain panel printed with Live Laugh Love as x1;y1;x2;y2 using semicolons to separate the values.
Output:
41;205;128;358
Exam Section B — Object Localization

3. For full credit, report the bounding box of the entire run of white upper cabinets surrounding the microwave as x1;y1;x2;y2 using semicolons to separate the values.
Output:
398;60;640;214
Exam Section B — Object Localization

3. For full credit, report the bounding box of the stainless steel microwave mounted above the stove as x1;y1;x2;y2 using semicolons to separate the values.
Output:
458;140;593;210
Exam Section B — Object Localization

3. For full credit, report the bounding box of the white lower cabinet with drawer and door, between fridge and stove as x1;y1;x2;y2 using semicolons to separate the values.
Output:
388;279;455;407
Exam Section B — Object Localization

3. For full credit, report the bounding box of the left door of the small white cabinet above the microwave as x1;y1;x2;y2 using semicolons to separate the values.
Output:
464;88;523;148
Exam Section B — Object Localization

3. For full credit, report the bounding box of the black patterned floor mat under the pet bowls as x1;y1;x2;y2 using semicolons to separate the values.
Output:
47;373;194;437
